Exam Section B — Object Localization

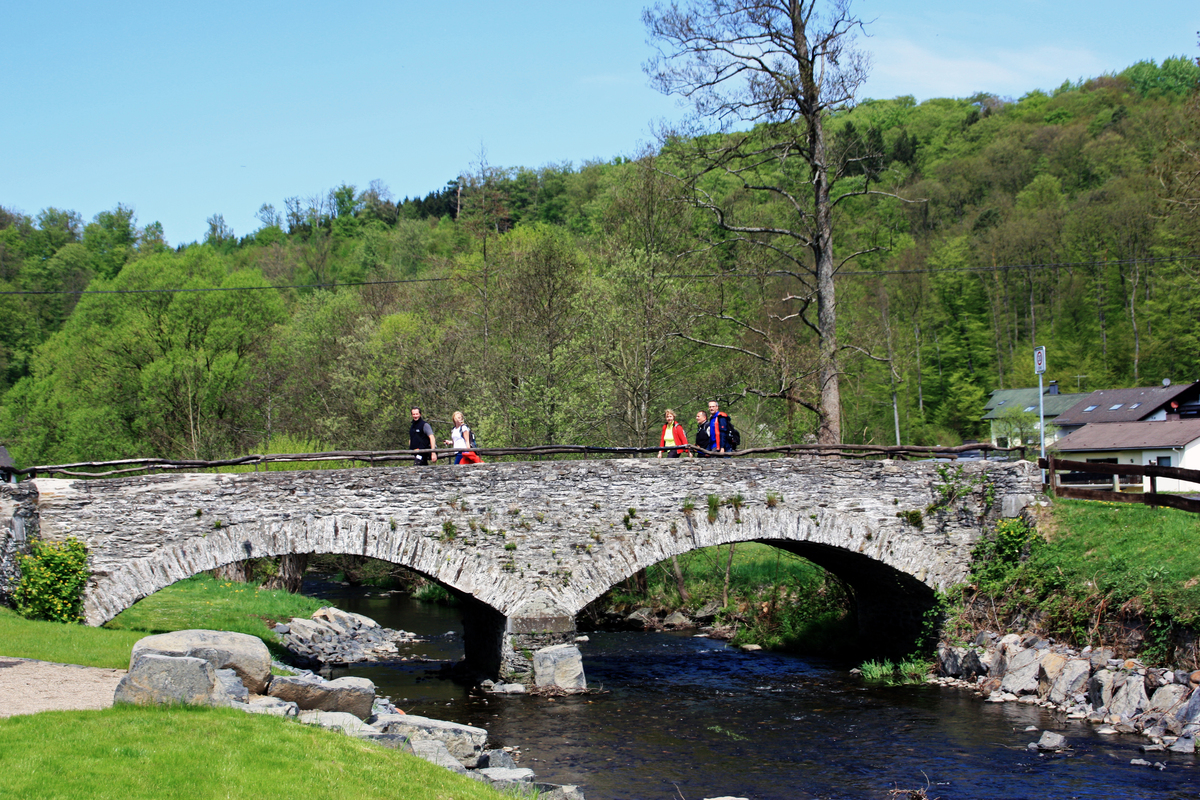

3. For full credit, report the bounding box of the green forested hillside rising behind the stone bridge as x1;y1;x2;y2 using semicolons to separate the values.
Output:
0;58;1200;465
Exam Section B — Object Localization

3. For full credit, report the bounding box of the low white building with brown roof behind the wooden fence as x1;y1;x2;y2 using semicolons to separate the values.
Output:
1054;419;1200;492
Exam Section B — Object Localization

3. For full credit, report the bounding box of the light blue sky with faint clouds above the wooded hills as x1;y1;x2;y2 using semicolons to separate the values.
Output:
0;0;1200;245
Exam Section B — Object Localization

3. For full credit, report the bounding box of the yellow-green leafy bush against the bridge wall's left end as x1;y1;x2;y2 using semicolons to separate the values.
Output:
13;539;89;622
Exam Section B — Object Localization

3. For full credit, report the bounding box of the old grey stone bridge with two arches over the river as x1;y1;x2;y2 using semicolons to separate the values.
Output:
0;457;1042;674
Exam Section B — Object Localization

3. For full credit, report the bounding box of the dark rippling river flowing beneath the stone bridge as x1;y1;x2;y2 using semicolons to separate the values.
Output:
305;582;1200;800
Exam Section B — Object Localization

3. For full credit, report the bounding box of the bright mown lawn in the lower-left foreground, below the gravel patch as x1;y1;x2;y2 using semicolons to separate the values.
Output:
0;705;506;800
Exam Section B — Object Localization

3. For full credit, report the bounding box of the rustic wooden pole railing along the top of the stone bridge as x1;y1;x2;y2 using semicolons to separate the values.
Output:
0;443;1025;482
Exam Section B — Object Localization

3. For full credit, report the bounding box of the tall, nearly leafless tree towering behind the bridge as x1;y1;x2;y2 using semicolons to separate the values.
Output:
643;0;890;444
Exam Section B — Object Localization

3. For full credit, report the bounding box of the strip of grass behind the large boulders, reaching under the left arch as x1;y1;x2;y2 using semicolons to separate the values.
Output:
0;575;323;671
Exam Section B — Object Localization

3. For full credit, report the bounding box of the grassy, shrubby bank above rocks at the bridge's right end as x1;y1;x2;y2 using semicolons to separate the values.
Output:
949;499;1200;663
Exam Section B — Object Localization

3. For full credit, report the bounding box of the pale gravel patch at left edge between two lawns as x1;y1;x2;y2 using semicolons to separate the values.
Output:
0;656;125;717
